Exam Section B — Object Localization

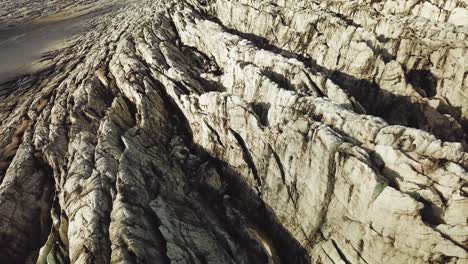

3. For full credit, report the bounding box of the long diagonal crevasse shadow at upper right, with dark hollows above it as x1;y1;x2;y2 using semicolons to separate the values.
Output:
210;21;468;142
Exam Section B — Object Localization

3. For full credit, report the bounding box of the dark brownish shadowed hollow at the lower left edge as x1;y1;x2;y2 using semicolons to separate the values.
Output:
0;153;56;263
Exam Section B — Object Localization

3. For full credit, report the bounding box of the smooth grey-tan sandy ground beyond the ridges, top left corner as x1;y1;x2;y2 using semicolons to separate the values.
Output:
0;1;128;83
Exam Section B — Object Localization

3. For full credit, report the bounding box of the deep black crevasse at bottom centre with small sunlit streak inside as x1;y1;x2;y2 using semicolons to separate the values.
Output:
186;146;311;264
